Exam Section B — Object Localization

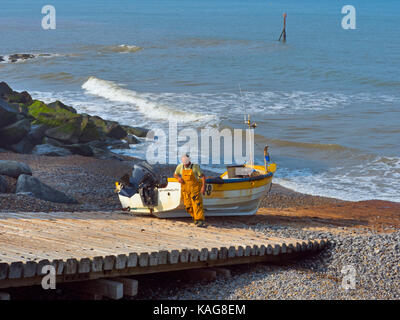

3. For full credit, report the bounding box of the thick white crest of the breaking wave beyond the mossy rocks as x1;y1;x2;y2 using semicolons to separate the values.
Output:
82;77;218;123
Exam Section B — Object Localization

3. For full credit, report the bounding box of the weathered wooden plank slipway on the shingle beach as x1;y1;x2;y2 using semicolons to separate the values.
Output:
0;212;326;288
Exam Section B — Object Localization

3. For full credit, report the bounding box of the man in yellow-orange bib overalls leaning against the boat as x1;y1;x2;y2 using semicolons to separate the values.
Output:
174;154;206;227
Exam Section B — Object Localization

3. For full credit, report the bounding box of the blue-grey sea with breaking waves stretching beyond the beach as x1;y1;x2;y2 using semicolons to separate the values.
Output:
0;0;400;201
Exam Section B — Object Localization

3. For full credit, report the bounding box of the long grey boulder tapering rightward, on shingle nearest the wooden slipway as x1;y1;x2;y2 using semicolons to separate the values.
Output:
15;174;78;203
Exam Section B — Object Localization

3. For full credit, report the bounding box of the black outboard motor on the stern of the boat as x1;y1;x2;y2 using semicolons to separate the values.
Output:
120;161;168;207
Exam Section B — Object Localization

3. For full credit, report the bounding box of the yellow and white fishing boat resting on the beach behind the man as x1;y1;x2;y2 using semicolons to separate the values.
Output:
116;163;276;218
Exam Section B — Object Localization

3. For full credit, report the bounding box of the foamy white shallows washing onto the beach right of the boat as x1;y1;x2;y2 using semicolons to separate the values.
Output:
274;157;400;202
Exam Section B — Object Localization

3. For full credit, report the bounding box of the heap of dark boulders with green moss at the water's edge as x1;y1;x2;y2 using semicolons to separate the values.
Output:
0;82;149;159
